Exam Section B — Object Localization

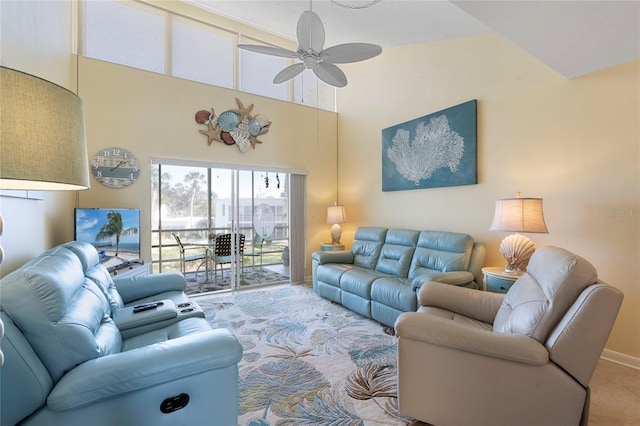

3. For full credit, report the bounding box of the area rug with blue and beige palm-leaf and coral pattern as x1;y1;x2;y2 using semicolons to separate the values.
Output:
197;285;412;426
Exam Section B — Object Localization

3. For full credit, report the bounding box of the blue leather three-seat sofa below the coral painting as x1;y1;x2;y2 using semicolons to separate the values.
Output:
312;227;485;327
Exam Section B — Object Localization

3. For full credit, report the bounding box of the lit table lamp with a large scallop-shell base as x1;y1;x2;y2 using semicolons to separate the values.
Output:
489;193;549;274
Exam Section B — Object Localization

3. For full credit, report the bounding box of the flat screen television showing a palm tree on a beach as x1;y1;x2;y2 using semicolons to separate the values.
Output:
75;208;141;271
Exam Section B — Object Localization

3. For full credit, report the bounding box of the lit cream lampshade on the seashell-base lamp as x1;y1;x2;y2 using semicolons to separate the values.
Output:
489;198;549;234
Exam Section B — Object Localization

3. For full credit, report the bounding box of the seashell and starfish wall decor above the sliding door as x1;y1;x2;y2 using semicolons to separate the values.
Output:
195;98;271;152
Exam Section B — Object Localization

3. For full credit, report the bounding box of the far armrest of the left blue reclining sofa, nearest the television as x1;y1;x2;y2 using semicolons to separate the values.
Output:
113;272;186;303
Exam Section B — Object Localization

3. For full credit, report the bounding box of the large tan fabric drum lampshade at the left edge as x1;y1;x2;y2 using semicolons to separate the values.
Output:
0;67;89;191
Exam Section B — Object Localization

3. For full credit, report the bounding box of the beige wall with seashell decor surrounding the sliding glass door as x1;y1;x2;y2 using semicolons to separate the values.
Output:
79;57;337;275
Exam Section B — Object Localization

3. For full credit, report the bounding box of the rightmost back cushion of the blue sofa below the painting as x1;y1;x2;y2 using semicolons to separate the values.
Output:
409;231;473;279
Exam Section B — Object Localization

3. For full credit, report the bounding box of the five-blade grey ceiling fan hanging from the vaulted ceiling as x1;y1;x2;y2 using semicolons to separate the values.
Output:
238;6;382;87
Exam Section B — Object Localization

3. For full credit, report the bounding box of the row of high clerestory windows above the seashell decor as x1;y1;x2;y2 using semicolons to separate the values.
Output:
78;0;335;111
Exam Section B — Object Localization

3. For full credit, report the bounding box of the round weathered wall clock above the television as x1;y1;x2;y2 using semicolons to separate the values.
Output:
91;148;140;188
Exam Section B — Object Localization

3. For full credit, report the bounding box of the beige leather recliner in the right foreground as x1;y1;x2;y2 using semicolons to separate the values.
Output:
396;246;623;426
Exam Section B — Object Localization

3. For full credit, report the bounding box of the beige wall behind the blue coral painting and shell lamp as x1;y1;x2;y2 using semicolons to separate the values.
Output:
338;35;640;357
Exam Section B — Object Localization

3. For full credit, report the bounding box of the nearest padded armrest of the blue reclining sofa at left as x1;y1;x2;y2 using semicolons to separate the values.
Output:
47;329;242;411
